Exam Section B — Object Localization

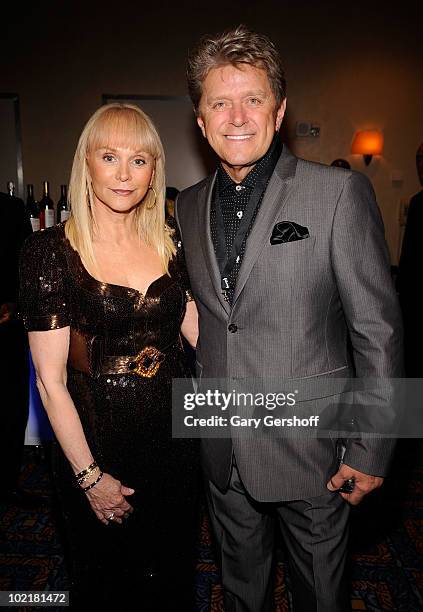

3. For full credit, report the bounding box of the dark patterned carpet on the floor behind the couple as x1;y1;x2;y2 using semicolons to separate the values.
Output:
0;441;423;612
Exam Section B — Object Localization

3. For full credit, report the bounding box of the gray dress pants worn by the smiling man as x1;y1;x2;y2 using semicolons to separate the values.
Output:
206;463;351;612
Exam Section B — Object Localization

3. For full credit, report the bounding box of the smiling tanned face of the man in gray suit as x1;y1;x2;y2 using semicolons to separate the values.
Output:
197;64;286;182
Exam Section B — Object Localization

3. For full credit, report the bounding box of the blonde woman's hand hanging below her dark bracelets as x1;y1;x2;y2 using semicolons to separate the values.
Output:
81;472;135;525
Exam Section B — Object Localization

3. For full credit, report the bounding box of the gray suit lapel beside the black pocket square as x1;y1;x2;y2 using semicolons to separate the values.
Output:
232;145;298;307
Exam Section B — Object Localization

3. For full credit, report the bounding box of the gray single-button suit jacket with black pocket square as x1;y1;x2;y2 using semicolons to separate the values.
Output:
176;147;402;501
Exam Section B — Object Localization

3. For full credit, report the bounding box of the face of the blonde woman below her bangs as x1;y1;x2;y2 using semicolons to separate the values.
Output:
87;147;155;213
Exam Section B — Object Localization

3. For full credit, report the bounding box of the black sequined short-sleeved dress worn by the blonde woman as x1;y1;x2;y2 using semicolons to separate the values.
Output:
20;220;199;609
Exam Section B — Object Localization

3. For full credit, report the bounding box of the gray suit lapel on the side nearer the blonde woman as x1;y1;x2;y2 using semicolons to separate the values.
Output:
197;172;230;316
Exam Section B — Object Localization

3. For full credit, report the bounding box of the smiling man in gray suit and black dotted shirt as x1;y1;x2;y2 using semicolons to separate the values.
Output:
176;26;402;612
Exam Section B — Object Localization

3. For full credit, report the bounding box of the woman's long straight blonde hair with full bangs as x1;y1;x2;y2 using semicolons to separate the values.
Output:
65;103;176;275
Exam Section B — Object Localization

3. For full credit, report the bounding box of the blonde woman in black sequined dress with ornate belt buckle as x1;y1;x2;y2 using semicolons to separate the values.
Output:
20;104;202;610
